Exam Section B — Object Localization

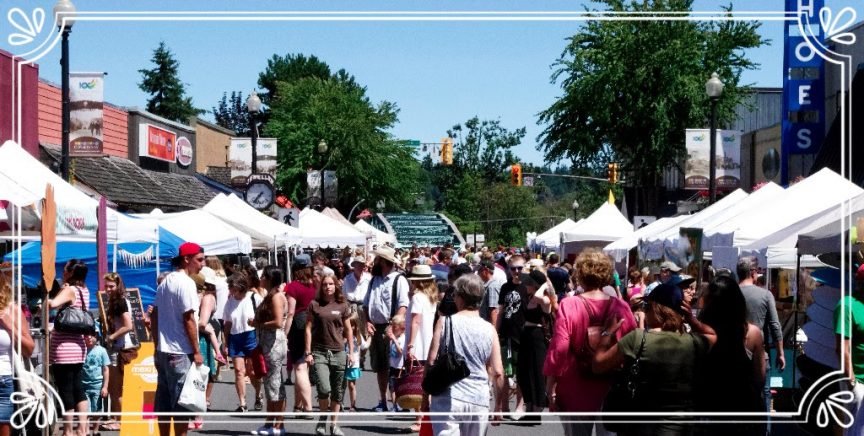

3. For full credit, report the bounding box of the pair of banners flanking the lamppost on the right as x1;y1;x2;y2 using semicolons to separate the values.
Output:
684;129;741;190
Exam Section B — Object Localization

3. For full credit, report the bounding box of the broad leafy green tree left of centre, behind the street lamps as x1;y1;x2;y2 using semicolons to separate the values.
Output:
265;76;421;211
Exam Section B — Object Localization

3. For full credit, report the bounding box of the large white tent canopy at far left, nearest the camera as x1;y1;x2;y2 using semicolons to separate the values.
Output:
0;141;158;242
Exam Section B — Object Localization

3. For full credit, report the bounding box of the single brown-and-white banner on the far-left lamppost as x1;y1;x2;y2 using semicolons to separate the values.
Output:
69;73;105;157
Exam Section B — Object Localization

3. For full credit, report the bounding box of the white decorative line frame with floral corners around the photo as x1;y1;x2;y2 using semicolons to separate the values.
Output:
0;0;857;428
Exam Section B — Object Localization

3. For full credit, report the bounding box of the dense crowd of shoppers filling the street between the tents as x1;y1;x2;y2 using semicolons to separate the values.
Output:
0;238;785;436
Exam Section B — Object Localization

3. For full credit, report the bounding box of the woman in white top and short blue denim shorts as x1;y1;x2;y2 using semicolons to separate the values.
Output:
222;273;264;413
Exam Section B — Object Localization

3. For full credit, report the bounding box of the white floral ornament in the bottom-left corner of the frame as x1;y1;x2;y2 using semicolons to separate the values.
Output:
10;371;63;430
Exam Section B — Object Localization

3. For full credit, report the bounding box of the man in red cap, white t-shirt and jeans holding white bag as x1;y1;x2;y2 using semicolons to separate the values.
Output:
151;242;205;436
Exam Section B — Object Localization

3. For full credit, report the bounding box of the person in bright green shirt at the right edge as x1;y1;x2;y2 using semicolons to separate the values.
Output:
834;265;864;435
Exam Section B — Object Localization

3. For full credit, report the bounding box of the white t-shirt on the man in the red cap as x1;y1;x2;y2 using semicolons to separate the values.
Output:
153;271;200;354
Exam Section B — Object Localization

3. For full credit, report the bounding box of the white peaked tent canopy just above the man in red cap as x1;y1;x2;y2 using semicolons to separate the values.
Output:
134;209;252;256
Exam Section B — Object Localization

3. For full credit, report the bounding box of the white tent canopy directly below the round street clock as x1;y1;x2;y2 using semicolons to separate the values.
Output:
203;193;300;250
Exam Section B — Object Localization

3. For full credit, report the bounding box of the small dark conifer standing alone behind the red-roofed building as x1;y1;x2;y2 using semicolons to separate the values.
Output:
138;41;205;124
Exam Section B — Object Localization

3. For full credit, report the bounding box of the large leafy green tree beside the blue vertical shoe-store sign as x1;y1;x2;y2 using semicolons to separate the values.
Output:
538;0;768;212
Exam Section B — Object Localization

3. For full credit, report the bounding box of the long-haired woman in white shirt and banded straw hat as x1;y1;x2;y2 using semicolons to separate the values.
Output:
405;265;438;432
